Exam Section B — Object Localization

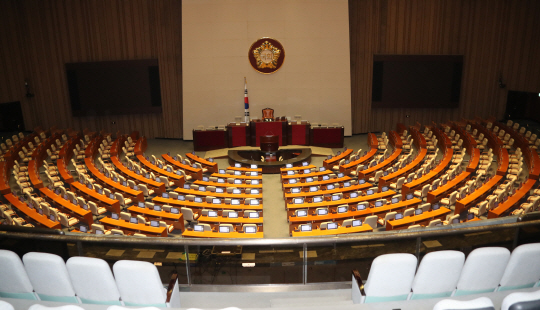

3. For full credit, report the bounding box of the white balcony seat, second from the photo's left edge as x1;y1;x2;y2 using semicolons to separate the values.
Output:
22;252;79;303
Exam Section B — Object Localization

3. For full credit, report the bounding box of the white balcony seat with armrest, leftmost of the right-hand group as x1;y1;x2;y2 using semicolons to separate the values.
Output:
352;253;417;303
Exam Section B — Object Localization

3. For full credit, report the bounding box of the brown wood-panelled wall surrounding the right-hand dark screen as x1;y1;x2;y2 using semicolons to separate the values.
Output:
349;0;540;133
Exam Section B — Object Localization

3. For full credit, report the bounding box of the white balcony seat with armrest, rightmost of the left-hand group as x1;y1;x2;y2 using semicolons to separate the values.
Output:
113;260;180;308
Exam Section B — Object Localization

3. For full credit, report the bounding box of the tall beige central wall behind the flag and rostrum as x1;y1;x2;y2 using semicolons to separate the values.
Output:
182;0;351;140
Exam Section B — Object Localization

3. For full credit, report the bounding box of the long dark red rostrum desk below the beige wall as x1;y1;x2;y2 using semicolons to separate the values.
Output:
193;120;344;152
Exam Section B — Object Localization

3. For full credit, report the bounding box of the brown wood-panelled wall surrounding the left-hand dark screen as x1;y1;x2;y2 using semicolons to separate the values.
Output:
0;0;182;138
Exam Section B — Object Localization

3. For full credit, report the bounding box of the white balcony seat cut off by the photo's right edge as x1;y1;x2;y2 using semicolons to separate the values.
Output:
498;243;540;291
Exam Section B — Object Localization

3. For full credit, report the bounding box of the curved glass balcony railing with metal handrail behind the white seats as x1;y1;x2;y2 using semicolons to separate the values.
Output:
0;212;540;286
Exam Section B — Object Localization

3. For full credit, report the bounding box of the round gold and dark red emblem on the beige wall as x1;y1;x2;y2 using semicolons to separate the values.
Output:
248;38;285;74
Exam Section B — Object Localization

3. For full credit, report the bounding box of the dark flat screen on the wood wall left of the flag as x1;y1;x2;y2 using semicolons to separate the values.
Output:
66;59;161;116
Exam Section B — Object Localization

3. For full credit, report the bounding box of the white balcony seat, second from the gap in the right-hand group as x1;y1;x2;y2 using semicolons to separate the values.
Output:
411;251;465;299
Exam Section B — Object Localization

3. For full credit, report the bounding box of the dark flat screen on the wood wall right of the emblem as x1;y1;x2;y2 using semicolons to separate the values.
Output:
371;55;463;108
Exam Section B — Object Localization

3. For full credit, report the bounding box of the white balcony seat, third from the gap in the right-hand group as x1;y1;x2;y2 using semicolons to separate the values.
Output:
454;247;510;296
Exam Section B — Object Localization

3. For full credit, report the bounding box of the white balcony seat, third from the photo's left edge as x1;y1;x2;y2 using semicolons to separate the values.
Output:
66;257;122;305
